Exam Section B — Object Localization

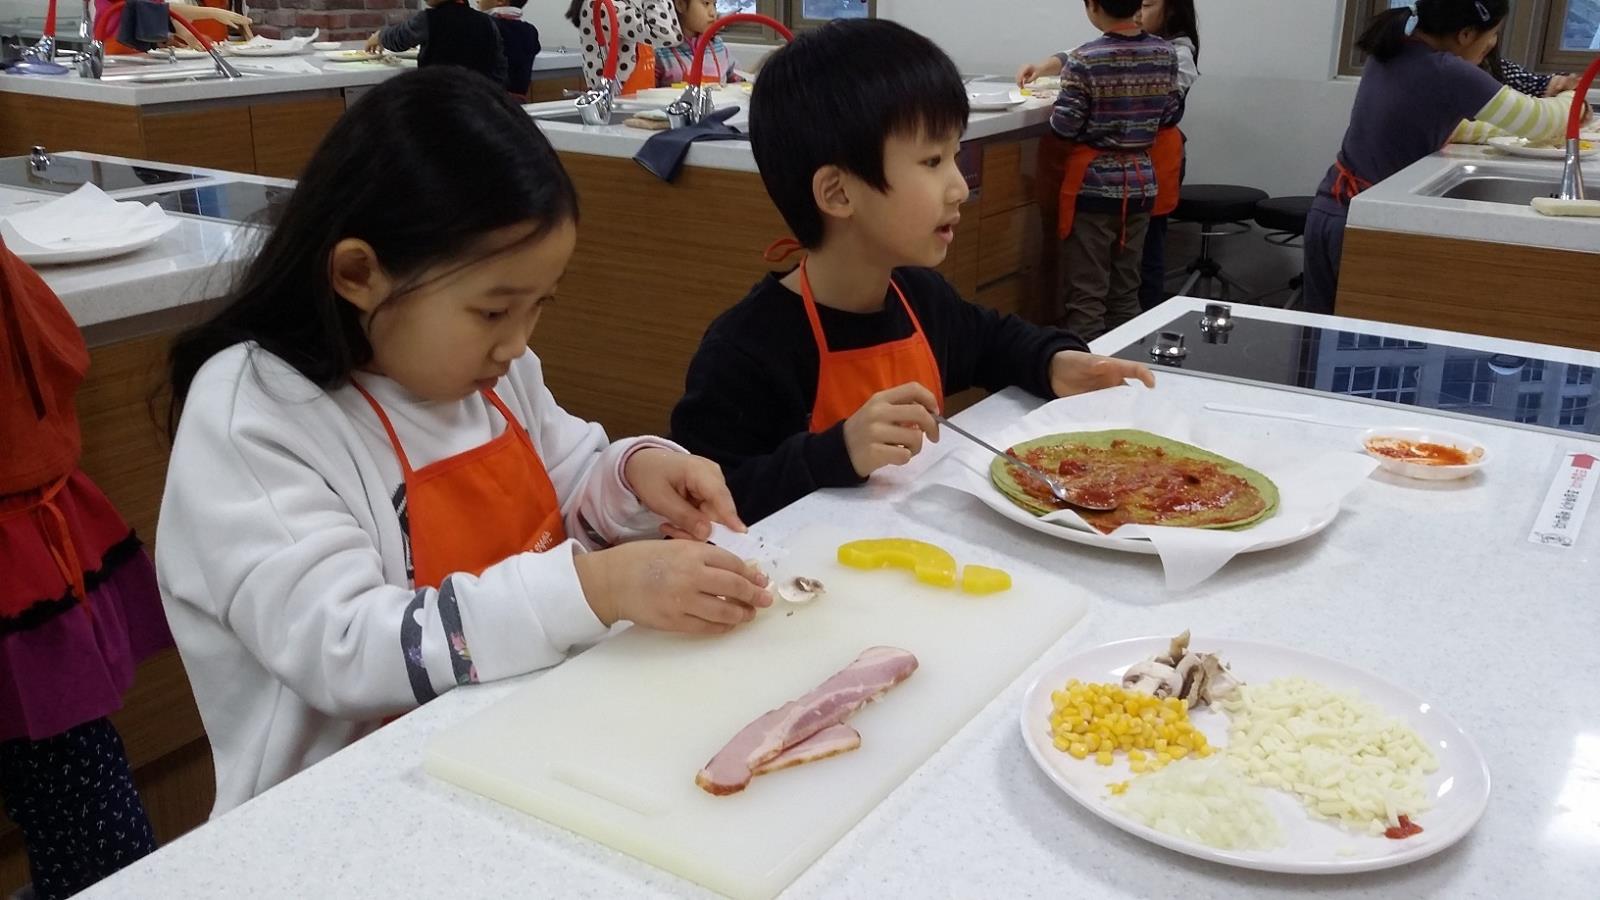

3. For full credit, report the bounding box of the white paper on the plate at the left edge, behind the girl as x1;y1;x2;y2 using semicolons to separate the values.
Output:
5;184;176;255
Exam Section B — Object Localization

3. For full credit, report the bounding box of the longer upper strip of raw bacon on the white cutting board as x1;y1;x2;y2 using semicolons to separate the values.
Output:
694;647;917;796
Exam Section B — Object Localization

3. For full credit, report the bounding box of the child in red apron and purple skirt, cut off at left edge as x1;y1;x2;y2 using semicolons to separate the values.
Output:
0;237;171;900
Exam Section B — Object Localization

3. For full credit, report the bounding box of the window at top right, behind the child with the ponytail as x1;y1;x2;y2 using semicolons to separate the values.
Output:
1339;0;1600;75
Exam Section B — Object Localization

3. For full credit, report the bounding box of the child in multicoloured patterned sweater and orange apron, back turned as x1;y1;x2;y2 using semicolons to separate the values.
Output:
1038;0;1182;340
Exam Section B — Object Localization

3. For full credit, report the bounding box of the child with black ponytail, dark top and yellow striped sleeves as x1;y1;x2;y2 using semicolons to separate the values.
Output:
1306;0;1571;312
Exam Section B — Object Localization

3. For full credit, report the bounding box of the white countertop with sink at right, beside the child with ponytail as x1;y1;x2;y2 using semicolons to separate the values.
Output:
1347;144;1600;253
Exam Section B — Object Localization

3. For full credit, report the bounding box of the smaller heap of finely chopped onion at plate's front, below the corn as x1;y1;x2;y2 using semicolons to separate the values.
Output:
1110;756;1283;850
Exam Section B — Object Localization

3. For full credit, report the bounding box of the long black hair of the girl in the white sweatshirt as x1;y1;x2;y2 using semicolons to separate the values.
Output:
166;66;578;434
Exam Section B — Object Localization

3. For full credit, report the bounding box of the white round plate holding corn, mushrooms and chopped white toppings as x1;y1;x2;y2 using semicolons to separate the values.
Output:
1021;637;1490;874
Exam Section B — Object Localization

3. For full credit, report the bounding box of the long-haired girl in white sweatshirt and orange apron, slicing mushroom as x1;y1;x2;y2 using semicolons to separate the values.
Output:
157;69;771;814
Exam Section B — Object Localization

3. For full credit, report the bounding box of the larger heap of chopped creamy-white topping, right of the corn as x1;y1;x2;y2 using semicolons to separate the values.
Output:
1219;677;1438;834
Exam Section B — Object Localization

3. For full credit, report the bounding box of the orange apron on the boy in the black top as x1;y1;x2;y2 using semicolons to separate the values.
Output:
800;261;944;434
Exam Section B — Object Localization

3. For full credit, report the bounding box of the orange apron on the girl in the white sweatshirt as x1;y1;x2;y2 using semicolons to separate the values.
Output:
352;381;566;588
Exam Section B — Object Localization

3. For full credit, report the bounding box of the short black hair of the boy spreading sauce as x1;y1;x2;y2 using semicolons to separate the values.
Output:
750;19;968;250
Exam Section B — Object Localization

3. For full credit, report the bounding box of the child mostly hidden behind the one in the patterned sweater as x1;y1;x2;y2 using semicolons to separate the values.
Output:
1138;0;1200;309
